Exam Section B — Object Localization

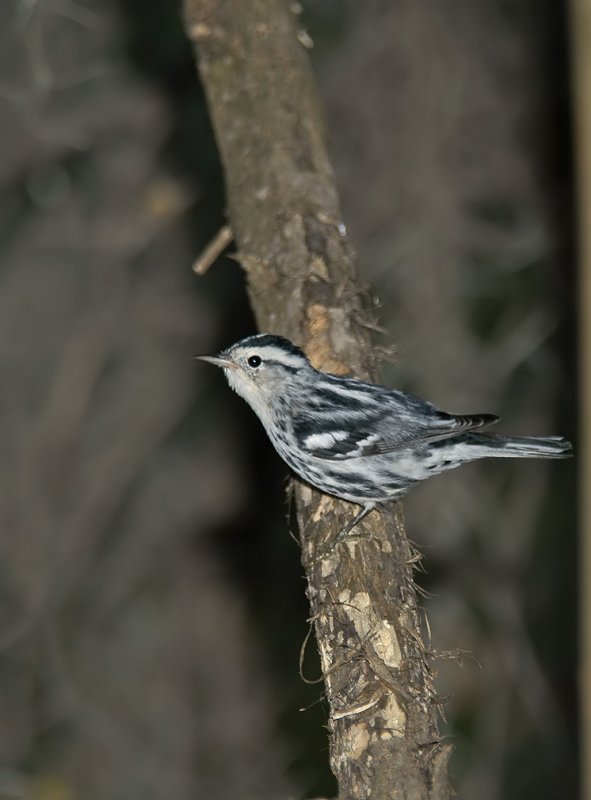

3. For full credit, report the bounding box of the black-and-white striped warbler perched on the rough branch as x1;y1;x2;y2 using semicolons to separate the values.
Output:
198;334;572;541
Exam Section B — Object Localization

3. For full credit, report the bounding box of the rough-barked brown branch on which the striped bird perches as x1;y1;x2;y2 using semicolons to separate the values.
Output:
185;0;449;800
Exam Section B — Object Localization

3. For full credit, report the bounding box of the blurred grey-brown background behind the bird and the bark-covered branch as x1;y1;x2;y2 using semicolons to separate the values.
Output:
0;0;577;800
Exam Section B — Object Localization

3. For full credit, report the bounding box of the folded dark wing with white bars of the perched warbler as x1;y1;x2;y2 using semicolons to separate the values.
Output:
292;381;499;461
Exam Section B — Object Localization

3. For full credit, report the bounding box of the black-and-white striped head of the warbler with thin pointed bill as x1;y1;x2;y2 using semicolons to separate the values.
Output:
197;333;313;419
